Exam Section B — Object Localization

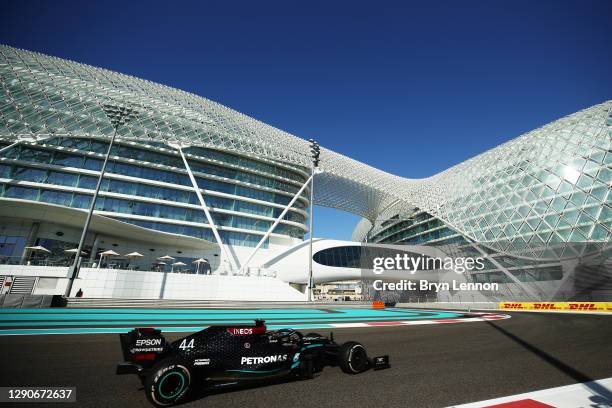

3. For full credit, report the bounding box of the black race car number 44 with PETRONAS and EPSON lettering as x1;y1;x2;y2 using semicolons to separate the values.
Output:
117;320;389;407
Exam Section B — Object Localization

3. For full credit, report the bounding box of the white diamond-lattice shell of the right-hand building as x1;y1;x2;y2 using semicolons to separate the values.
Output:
354;102;612;258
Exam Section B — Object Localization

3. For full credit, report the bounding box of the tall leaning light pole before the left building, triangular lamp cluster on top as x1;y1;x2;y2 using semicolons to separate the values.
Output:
65;105;137;297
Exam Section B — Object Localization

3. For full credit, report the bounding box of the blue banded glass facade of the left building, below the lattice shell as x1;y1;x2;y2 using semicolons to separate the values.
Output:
0;138;308;246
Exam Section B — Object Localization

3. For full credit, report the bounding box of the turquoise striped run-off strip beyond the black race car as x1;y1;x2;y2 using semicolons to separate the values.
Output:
0;305;510;336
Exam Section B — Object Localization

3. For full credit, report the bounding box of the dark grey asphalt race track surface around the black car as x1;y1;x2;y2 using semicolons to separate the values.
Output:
0;313;612;408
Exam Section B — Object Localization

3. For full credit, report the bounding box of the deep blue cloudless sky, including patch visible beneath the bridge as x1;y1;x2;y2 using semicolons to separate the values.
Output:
0;0;612;239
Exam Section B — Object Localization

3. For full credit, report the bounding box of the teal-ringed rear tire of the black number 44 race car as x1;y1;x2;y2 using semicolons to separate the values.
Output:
144;357;192;407
